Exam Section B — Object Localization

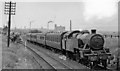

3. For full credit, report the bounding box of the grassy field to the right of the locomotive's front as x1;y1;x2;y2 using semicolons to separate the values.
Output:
104;37;120;69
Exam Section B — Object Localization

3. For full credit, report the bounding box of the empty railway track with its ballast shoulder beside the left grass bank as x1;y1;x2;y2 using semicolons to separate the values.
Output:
22;40;72;70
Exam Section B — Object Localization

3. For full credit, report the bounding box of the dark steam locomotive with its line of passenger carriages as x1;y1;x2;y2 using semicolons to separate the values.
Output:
26;29;112;68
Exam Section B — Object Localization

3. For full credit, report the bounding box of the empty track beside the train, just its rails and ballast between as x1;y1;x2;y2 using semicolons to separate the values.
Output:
23;41;72;70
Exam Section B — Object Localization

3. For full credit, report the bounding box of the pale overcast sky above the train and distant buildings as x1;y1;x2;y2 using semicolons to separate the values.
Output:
0;0;118;31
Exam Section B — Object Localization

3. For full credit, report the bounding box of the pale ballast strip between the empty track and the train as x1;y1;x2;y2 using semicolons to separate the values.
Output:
29;41;90;70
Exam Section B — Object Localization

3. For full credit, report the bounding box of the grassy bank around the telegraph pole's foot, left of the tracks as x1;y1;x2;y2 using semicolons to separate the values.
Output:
2;37;40;69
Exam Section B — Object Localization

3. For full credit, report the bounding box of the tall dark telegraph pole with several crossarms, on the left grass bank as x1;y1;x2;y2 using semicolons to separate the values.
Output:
4;1;16;47
